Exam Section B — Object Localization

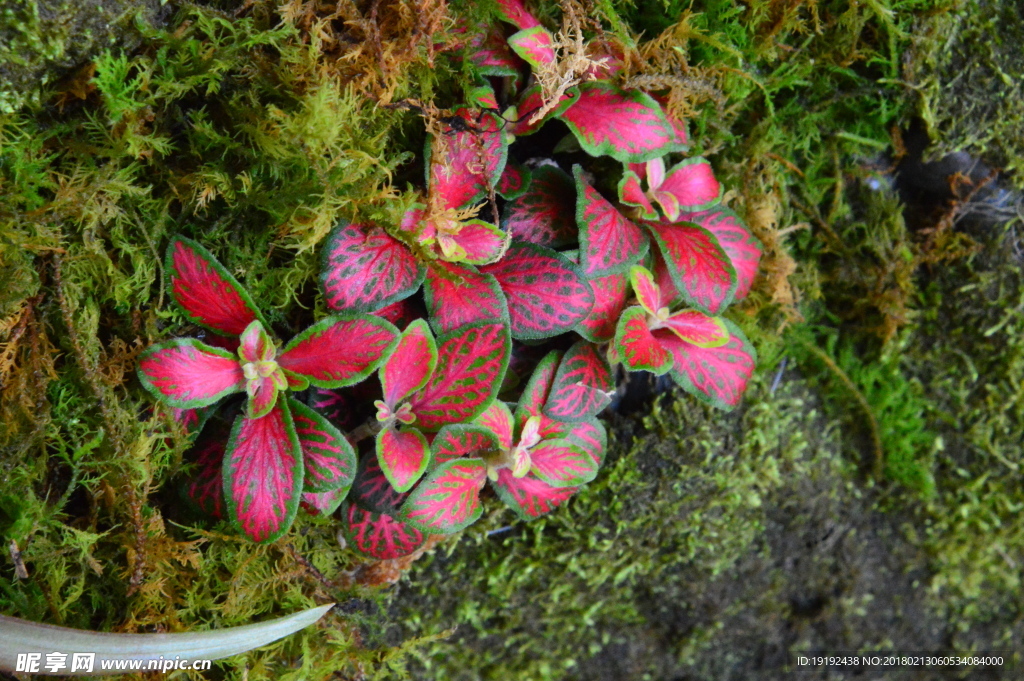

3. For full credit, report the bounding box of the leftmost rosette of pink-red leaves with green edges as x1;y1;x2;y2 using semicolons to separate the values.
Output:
138;239;398;542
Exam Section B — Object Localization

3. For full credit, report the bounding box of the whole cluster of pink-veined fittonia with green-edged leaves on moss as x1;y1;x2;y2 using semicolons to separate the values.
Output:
139;0;761;558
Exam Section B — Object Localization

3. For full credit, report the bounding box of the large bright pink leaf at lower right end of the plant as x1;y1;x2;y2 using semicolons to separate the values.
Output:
654;320;757;411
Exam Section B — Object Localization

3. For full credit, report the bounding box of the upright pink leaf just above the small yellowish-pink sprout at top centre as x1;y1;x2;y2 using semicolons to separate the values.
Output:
427;109;508;210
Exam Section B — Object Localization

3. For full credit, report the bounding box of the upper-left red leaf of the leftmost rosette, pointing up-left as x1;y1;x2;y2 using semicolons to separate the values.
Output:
164;237;263;336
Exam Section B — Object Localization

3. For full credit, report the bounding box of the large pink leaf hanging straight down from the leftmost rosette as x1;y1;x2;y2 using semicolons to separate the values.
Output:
224;399;303;542
